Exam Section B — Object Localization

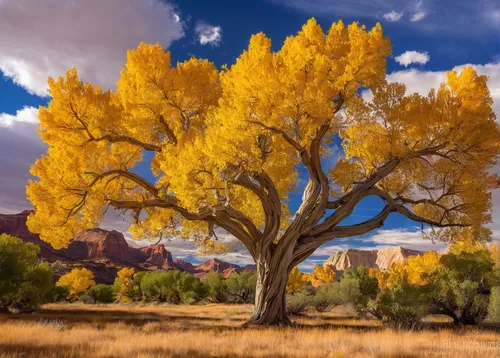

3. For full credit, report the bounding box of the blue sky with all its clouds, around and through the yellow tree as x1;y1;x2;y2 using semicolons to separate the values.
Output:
0;0;500;270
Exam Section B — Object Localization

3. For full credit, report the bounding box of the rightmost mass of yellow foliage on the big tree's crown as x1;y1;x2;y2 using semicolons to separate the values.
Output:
330;66;500;225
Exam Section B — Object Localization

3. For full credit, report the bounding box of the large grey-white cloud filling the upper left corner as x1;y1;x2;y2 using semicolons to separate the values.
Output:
0;0;184;96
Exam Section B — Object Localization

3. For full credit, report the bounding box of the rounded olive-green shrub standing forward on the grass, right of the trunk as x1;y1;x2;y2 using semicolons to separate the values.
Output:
377;280;429;329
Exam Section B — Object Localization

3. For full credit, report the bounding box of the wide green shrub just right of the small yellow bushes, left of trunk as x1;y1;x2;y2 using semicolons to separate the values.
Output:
140;270;207;304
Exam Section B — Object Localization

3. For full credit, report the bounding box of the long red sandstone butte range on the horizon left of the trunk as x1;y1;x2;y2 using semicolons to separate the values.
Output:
0;210;255;284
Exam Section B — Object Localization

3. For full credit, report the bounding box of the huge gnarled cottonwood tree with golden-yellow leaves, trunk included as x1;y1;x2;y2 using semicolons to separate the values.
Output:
27;19;499;324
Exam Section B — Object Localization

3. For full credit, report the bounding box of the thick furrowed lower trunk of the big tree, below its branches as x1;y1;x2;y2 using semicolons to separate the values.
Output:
248;253;292;326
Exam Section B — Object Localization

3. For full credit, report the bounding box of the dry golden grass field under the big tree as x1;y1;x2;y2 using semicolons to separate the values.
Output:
0;304;500;358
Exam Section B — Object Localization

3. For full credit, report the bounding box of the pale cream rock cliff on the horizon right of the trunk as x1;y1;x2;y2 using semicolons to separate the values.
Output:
324;246;424;272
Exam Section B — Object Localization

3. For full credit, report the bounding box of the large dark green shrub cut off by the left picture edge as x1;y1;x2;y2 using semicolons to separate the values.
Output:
0;234;53;312
